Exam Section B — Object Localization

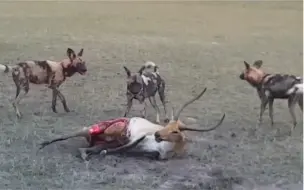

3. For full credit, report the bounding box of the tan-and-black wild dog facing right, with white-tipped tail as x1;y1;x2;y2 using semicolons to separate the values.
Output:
0;48;87;118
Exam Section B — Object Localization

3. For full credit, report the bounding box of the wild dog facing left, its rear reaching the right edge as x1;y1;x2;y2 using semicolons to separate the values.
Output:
239;60;303;132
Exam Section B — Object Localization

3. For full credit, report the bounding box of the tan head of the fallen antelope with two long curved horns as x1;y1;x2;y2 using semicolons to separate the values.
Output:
154;88;225;142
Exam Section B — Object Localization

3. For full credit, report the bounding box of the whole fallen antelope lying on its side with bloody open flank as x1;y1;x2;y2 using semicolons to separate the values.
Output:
40;88;225;160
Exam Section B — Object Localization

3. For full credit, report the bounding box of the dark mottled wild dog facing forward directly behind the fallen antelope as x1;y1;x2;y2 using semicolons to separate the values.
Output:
124;61;168;123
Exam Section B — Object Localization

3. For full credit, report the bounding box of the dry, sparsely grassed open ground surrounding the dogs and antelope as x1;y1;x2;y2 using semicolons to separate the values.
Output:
0;2;303;190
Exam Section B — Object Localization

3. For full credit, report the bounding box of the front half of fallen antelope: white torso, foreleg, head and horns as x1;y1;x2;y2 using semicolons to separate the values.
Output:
100;88;225;159
